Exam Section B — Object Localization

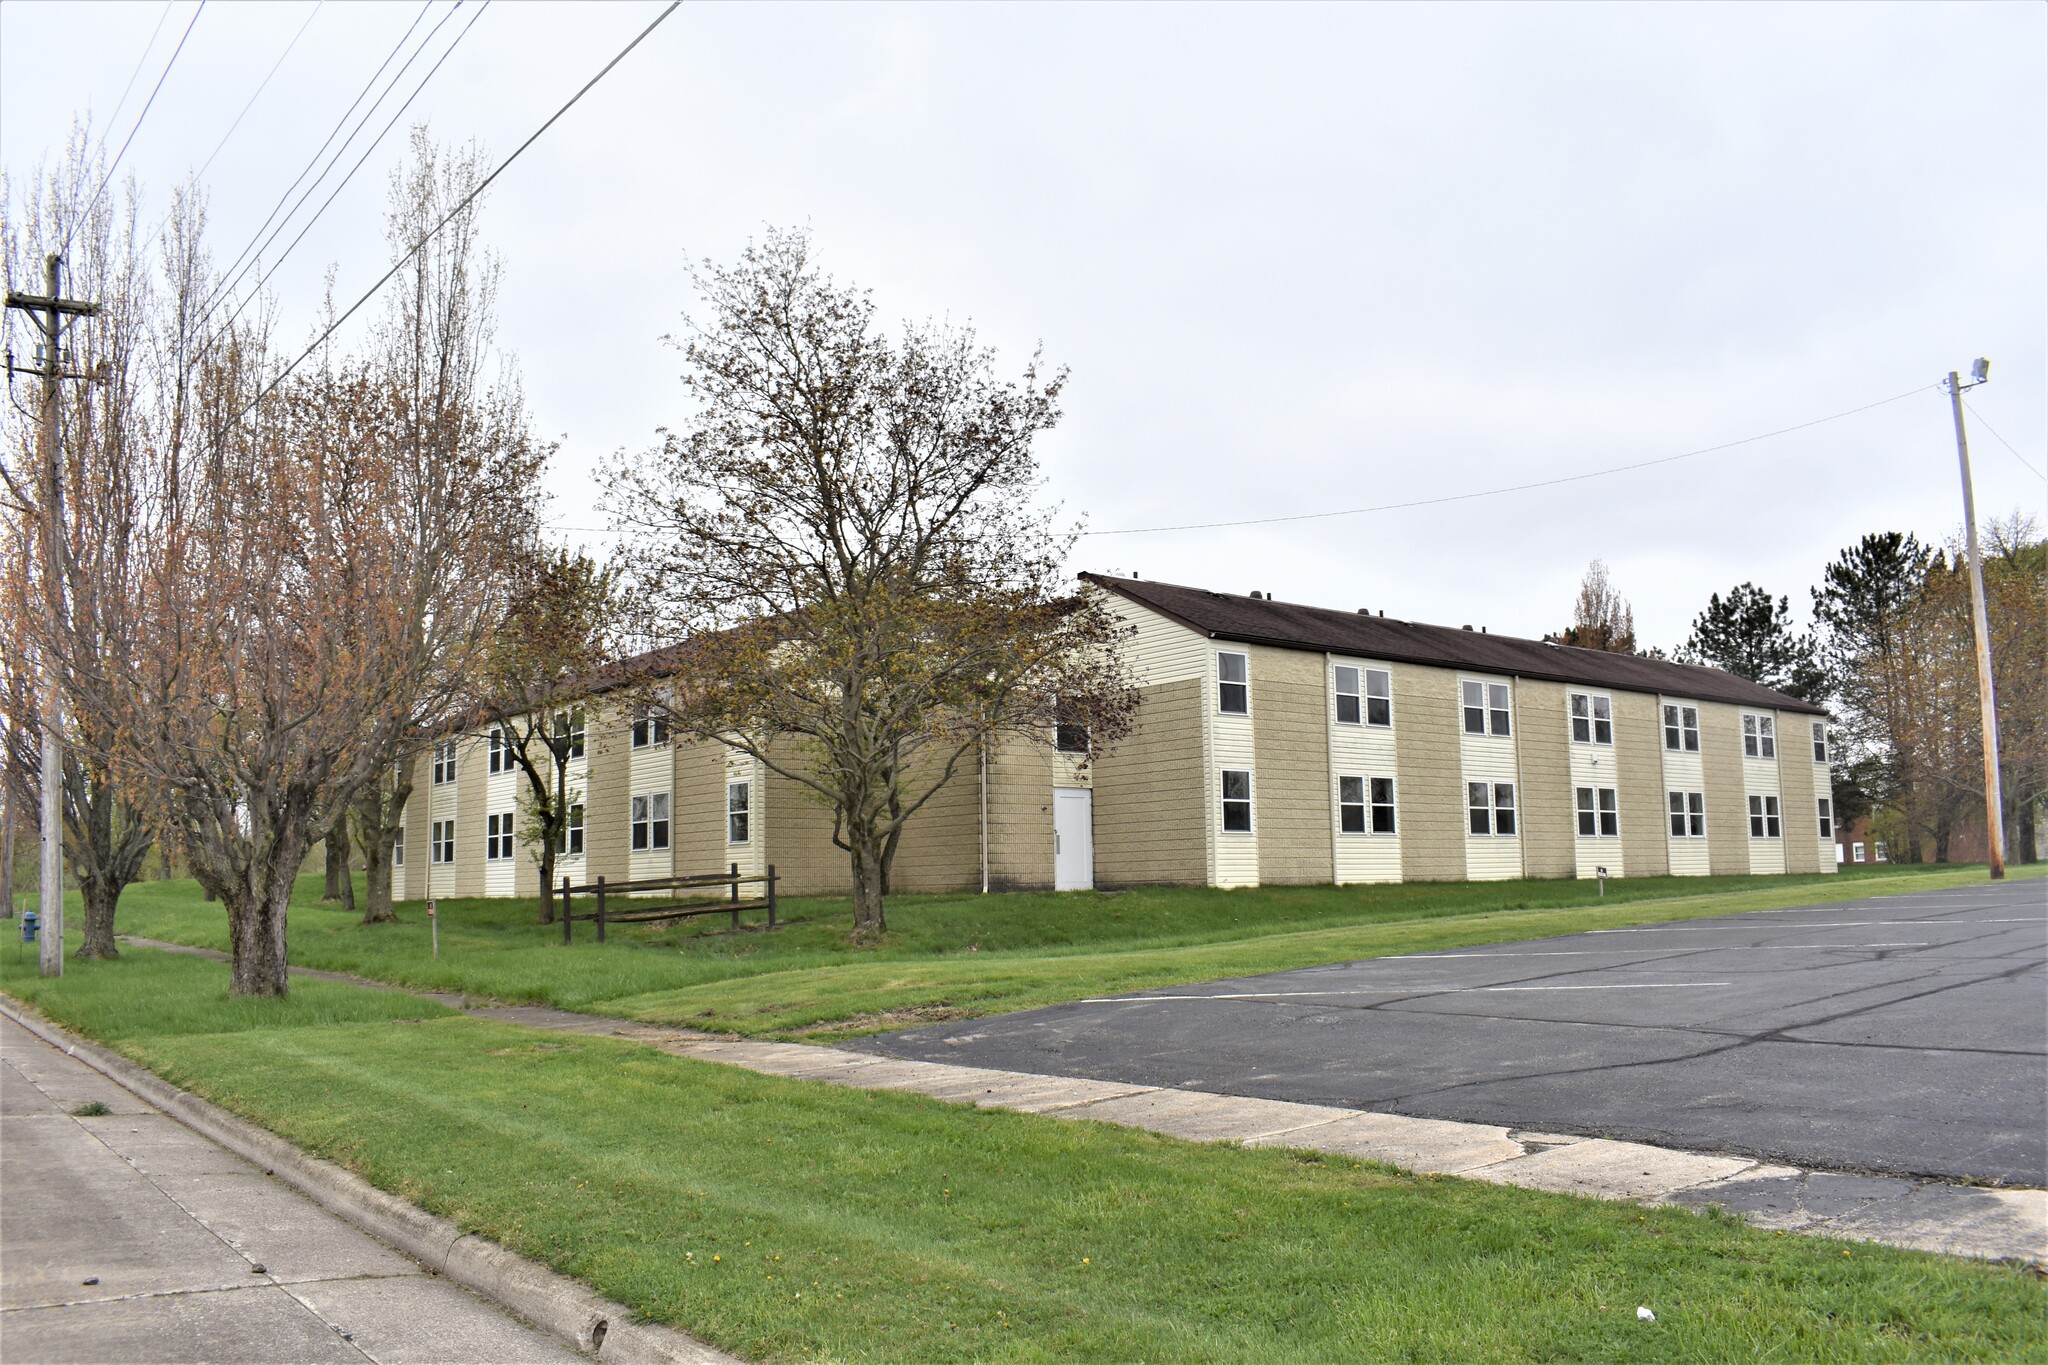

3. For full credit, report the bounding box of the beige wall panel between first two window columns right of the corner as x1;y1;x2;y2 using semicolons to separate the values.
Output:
1251;645;1335;886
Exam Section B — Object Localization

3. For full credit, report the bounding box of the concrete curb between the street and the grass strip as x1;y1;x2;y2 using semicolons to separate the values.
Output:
0;997;739;1365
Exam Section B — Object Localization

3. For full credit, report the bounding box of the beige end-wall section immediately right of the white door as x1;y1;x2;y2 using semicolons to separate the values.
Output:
1094;677;1208;888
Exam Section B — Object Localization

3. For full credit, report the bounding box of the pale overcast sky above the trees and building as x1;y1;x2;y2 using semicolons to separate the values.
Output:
0;0;2048;647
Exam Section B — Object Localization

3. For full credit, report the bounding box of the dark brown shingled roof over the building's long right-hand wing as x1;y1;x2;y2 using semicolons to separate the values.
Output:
1081;573;1827;716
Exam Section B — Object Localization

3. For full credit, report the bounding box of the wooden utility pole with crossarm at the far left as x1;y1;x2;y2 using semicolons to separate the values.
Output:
6;252;100;976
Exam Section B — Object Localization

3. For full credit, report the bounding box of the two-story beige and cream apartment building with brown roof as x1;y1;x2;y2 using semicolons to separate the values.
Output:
395;575;1835;898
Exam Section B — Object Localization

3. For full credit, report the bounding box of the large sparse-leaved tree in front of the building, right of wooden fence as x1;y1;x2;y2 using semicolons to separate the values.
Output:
610;231;1135;937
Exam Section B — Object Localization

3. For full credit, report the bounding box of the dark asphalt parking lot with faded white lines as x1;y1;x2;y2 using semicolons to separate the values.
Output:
860;880;2048;1187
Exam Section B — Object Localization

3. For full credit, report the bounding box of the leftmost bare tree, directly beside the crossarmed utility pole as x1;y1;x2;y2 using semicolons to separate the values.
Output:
0;129;156;958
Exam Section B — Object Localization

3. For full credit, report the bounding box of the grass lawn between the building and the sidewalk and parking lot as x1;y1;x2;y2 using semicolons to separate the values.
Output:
75;866;2042;1040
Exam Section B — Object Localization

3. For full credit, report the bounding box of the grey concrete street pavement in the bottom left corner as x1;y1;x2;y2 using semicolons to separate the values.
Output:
0;1019;584;1365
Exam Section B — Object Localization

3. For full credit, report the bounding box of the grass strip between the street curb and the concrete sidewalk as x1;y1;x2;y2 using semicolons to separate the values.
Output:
0;941;2048;1363
